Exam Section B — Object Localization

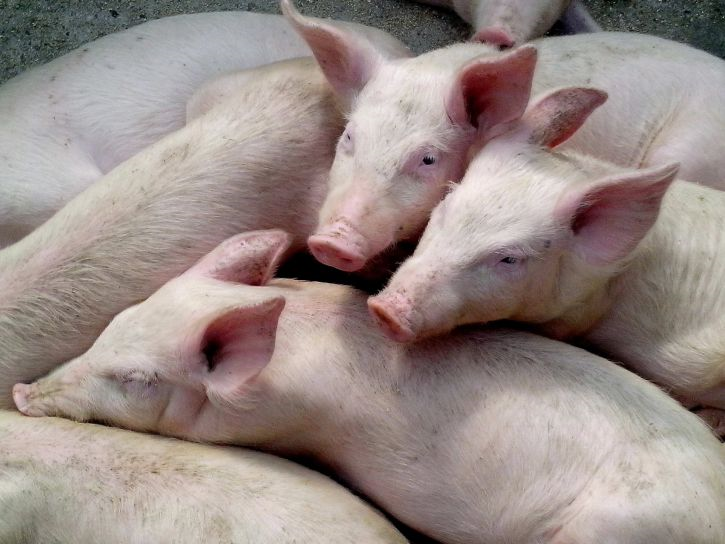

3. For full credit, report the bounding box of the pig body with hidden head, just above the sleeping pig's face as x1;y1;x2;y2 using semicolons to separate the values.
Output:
0;58;344;408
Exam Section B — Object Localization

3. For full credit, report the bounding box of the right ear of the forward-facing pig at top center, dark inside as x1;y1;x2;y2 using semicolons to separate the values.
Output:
446;45;537;134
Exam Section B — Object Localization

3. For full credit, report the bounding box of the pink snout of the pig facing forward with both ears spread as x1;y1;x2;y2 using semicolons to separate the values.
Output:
307;221;371;272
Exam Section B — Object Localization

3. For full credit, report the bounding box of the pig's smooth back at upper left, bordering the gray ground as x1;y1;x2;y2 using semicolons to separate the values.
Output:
0;12;408;248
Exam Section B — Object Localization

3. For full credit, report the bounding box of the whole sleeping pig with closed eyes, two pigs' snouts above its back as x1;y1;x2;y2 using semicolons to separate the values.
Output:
14;231;725;544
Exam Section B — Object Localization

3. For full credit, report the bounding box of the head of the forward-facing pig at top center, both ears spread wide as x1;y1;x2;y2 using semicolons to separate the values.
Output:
282;0;536;271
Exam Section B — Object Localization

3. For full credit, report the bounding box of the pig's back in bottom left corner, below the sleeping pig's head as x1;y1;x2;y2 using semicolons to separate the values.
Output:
0;411;407;544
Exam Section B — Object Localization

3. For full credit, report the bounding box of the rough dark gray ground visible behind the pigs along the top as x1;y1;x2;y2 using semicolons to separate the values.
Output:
0;0;725;83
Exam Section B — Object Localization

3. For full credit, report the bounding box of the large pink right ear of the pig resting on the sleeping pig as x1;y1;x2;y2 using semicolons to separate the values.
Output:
555;163;680;266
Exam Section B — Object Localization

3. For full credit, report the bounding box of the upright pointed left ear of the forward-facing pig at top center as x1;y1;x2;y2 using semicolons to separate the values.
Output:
280;0;383;104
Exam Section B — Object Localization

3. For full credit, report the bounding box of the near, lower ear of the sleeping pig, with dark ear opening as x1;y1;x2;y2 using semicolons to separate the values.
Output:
199;297;285;401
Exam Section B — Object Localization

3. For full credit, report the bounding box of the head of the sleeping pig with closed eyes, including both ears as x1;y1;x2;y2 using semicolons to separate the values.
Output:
13;231;291;441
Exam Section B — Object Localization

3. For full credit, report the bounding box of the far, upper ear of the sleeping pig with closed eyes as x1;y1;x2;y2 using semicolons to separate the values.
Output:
186;230;292;285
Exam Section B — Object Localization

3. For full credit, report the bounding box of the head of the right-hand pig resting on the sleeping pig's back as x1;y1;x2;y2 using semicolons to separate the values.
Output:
369;88;678;342
